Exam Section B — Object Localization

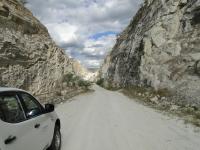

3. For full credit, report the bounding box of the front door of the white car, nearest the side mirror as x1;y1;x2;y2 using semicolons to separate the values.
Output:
18;92;53;150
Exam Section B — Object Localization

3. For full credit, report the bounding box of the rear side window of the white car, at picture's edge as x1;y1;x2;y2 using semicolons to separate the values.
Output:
0;95;26;123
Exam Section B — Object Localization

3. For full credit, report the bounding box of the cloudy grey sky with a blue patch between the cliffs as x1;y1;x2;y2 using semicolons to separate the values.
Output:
26;0;142;68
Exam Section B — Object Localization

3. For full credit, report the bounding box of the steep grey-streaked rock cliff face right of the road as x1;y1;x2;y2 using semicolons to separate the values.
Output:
100;0;200;105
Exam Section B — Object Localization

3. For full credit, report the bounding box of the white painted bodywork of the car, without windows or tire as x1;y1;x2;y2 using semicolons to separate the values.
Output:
0;88;58;150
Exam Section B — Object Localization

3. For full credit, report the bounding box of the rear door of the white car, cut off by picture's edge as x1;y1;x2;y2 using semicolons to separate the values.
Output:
0;92;39;150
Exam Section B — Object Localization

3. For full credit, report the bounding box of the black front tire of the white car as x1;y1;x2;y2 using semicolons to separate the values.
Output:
48;125;62;150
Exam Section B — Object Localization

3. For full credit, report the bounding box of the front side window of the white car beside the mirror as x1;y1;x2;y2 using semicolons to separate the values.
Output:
20;93;42;118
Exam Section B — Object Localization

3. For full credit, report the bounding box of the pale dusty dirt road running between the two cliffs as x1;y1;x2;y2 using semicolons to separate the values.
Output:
57;86;200;150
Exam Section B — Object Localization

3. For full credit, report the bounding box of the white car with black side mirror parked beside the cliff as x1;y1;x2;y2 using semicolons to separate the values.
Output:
0;88;61;150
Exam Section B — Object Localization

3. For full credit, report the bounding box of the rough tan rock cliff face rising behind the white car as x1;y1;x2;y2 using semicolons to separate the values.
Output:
0;0;87;102
